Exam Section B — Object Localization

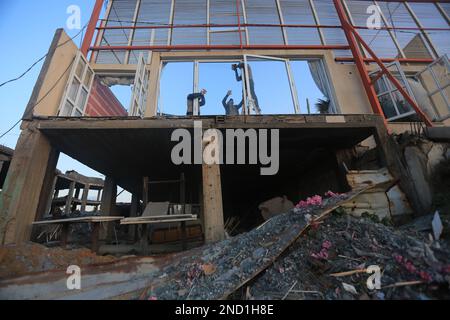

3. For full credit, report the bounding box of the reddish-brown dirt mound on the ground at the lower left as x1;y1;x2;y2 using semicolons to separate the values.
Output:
0;243;115;279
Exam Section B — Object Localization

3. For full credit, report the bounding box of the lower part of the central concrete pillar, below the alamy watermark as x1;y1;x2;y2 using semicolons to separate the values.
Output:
202;164;225;243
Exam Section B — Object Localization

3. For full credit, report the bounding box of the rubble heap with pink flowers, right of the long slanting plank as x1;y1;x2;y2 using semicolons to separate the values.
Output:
248;214;450;299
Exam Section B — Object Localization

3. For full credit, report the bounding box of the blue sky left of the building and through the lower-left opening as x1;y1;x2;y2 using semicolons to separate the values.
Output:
0;0;106;176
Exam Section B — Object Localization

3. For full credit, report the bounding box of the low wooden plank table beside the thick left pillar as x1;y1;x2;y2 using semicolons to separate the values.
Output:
33;216;124;252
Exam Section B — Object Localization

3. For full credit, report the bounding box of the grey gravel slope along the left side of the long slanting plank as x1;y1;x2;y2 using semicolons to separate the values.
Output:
142;192;357;300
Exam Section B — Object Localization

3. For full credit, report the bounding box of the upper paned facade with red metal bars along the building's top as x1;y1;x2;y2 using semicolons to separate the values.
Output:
96;0;450;64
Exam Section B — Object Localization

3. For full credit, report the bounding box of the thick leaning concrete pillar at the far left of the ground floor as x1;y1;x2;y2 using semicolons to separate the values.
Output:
0;123;59;244
